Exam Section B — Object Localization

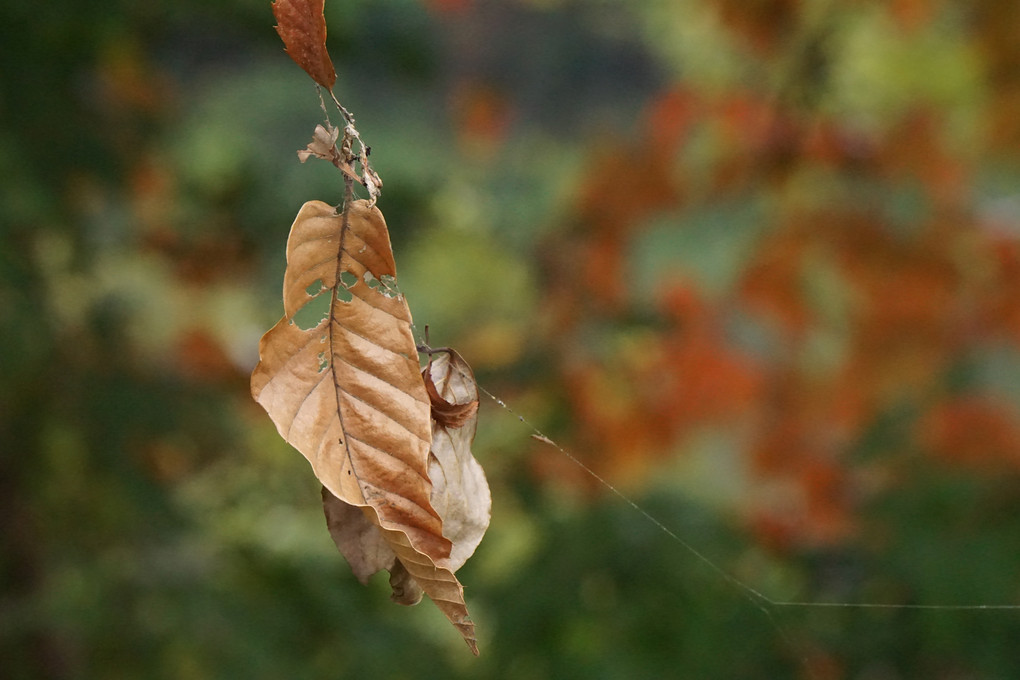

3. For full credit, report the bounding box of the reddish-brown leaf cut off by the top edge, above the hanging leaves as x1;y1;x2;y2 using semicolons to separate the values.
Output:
272;0;337;90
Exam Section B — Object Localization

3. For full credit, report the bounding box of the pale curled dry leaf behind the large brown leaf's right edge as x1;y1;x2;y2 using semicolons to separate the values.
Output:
424;350;493;572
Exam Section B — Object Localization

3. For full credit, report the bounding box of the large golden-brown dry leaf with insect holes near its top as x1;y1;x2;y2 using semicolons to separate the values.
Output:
252;201;477;653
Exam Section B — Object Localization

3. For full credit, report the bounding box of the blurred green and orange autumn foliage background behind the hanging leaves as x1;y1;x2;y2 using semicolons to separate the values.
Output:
0;0;1020;680
